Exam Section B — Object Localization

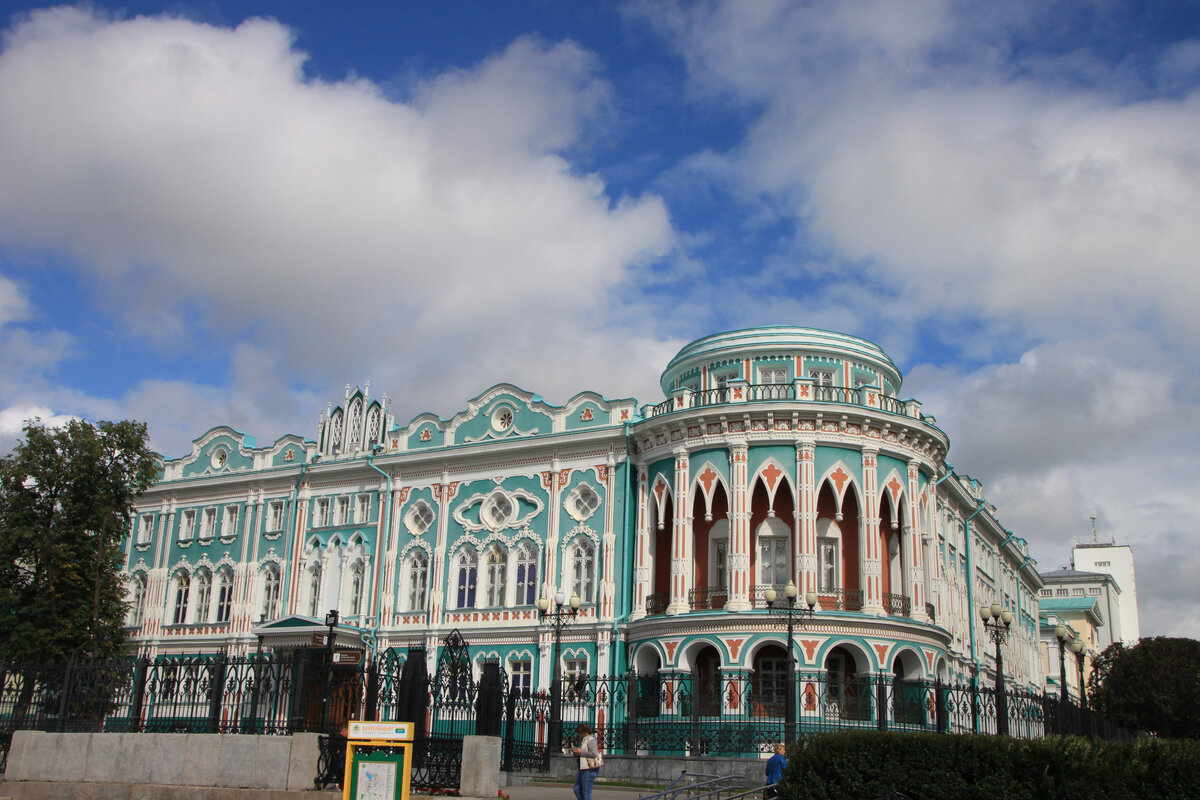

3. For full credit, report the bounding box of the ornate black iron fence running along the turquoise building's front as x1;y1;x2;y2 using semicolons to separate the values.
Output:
0;652;1128;788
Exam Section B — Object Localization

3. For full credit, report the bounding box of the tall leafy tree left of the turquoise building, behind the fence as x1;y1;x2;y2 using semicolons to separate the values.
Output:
0;420;158;662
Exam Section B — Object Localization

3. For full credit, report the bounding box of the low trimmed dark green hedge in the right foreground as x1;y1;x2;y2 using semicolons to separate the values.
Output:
779;730;1200;800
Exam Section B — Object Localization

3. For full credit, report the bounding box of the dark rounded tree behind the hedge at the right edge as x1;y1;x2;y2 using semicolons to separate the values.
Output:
1088;636;1200;739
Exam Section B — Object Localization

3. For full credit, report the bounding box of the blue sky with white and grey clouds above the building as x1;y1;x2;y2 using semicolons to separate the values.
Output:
0;0;1200;638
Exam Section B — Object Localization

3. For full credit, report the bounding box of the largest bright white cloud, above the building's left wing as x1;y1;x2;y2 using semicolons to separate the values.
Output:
0;8;674;435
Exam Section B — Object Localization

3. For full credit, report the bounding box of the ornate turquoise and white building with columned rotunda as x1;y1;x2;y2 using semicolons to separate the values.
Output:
125;327;1044;705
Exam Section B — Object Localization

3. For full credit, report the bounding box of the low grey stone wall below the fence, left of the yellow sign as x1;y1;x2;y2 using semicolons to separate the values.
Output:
5;730;318;790
